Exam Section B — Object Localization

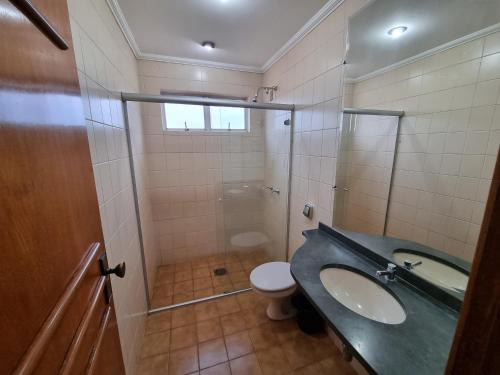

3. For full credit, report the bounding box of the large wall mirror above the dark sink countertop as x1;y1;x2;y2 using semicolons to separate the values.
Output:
333;0;500;297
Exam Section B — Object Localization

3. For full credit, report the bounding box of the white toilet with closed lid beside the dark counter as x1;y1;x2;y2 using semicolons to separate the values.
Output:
250;262;297;320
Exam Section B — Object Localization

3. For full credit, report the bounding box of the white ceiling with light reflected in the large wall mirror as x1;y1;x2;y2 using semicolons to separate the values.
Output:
346;0;500;79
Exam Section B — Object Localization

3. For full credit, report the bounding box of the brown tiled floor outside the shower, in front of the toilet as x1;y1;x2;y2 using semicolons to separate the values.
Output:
139;292;354;375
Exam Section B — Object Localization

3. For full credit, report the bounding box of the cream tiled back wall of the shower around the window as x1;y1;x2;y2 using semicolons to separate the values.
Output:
135;61;264;264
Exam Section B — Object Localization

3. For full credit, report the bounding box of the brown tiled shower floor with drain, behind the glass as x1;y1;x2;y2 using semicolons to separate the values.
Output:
151;250;271;308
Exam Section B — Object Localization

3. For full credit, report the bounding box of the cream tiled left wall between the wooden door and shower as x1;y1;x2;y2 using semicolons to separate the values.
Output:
69;0;157;374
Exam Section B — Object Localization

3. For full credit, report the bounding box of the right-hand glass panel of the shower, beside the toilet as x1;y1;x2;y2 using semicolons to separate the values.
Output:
211;109;291;294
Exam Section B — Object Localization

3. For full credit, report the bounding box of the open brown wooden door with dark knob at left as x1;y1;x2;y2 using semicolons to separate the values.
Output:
0;0;124;374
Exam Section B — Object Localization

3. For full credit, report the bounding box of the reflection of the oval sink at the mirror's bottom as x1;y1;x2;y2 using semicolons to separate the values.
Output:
393;250;469;293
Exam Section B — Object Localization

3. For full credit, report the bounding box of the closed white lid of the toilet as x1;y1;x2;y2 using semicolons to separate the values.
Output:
250;262;295;292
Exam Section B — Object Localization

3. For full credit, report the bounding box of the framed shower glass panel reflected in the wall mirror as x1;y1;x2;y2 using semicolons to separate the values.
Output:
333;113;399;235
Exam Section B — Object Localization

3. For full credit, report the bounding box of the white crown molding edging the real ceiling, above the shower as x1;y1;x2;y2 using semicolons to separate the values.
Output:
106;0;344;73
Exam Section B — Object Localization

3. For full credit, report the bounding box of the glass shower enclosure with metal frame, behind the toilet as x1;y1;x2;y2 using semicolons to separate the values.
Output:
122;94;293;312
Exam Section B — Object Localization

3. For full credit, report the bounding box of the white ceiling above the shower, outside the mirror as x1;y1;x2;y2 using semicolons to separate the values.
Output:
115;0;330;71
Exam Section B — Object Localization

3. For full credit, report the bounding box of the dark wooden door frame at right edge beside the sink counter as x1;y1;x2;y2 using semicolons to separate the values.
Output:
446;148;500;375
